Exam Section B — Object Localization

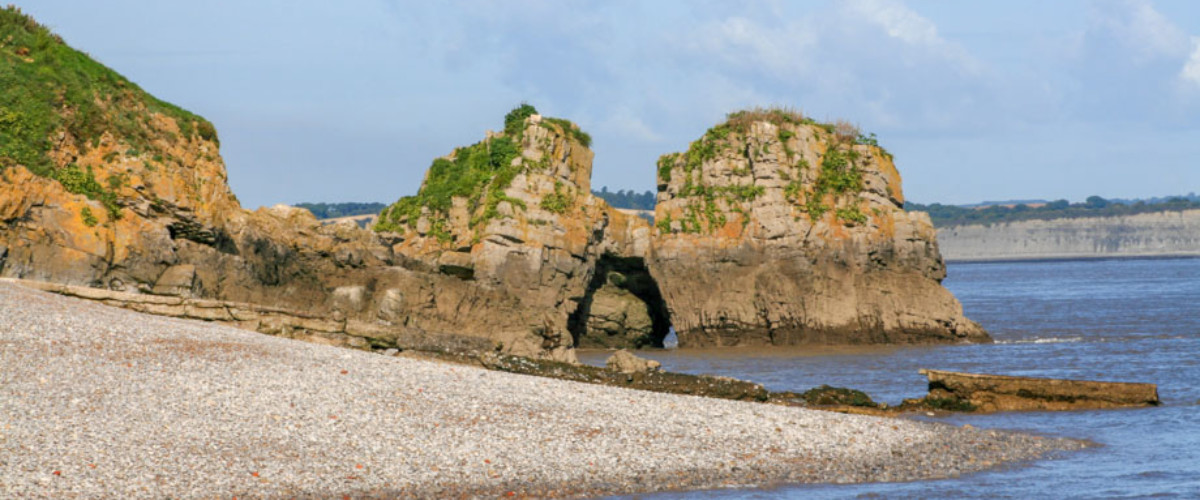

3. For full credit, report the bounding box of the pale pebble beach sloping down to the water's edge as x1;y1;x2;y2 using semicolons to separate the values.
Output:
0;283;1086;499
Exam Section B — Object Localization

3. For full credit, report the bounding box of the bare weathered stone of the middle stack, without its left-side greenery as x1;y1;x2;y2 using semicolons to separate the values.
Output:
377;115;649;360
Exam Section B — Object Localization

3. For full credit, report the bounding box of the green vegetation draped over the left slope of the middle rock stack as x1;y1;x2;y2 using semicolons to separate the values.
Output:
374;103;592;239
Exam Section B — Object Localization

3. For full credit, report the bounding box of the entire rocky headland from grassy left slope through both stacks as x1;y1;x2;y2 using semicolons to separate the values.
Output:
0;10;986;362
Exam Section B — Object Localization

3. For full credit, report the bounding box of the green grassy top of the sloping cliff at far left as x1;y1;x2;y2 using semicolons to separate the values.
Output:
0;6;216;176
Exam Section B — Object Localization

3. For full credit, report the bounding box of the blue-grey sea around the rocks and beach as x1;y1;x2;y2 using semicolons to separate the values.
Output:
581;259;1200;500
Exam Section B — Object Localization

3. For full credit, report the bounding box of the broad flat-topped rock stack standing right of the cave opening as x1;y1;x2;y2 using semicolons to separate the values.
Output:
649;110;989;347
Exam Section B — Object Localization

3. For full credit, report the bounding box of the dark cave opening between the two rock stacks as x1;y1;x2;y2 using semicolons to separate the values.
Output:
566;254;671;349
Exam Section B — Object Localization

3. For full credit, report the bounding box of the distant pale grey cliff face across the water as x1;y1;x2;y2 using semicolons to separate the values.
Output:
937;210;1200;261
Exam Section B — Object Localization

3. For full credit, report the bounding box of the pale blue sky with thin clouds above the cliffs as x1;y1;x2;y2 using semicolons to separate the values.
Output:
10;0;1200;207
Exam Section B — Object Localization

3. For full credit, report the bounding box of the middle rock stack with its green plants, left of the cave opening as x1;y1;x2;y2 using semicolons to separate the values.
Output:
376;106;666;357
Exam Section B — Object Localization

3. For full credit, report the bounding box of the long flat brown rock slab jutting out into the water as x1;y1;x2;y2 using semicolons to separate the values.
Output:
920;369;1159;411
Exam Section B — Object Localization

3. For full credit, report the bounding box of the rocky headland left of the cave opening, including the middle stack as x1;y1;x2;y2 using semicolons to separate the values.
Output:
0;10;649;361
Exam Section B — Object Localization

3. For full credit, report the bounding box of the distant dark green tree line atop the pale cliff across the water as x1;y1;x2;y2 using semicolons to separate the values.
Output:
905;197;1200;228
